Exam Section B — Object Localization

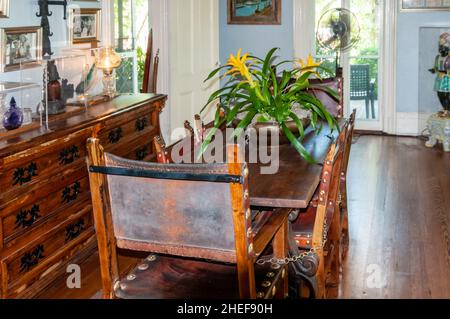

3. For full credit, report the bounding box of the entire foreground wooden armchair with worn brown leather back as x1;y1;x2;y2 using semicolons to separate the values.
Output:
88;139;289;298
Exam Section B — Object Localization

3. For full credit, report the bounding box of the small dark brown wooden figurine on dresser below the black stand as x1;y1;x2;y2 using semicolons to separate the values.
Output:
47;61;74;114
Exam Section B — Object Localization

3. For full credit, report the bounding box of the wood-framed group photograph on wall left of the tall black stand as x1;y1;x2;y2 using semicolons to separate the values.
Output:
0;27;42;72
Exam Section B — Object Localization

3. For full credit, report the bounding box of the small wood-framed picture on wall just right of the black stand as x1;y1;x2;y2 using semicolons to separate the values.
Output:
69;8;101;44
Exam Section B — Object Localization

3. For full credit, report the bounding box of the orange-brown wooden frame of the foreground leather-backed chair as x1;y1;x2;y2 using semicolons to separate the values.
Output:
87;138;289;298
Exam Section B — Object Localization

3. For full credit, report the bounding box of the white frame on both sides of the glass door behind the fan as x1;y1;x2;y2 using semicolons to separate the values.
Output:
293;0;398;134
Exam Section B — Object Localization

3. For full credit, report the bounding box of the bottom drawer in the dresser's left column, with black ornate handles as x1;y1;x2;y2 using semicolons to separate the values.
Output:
1;206;94;296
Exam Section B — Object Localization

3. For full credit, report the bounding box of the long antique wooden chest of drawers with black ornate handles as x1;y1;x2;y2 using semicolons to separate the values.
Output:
0;94;166;298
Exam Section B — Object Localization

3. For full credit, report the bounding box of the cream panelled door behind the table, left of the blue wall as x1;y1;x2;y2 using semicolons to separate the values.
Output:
169;0;219;140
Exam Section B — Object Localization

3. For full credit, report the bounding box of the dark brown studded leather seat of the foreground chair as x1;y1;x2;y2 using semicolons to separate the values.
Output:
114;255;286;299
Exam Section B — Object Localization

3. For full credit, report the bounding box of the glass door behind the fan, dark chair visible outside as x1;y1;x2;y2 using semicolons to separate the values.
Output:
315;0;383;130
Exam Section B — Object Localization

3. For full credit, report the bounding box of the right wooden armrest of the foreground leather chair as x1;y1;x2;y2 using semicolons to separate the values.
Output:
253;208;291;257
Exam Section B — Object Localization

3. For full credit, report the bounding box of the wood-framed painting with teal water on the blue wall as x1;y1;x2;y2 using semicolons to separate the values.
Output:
228;0;281;24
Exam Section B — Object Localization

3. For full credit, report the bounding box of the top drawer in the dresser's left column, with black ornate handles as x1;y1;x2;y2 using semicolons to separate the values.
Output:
0;129;92;198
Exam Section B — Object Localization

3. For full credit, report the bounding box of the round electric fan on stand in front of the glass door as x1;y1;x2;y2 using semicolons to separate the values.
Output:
316;8;360;72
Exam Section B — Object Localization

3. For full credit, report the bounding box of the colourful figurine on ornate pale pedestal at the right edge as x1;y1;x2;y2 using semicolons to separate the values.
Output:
425;32;450;152
